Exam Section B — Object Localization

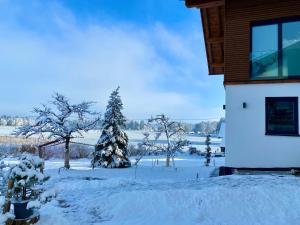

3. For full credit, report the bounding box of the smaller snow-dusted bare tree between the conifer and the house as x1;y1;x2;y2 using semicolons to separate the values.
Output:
143;114;189;167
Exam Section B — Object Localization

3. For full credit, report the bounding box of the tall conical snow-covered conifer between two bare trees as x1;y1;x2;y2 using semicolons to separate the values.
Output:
92;87;131;168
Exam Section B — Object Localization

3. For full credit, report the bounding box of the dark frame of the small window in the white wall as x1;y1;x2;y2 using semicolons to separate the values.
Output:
265;97;299;136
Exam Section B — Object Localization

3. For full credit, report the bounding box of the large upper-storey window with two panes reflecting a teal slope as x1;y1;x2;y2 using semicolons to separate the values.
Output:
251;18;300;79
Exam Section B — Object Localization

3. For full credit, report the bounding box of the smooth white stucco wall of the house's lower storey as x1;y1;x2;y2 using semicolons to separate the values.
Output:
226;83;300;168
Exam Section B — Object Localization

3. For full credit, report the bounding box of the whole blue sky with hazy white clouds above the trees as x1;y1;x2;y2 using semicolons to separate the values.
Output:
0;0;224;119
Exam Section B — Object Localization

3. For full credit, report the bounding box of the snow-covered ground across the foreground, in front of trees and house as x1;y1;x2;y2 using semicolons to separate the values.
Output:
1;156;300;225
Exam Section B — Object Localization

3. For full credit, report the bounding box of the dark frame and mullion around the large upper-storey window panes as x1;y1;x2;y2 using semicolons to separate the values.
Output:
249;16;300;80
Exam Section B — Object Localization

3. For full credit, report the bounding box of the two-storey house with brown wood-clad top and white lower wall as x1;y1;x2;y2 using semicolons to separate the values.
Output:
185;0;300;170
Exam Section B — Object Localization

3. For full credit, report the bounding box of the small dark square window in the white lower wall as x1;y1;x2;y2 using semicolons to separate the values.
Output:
266;97;298;135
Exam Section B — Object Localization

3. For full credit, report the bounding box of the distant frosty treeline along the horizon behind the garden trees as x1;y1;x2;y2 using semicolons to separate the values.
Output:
0;115;224;134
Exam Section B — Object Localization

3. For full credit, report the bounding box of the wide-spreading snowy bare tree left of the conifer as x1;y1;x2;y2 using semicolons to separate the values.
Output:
14;93;100;169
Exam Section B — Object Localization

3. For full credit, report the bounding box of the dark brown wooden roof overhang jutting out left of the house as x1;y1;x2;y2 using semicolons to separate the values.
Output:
185;0;225;75
